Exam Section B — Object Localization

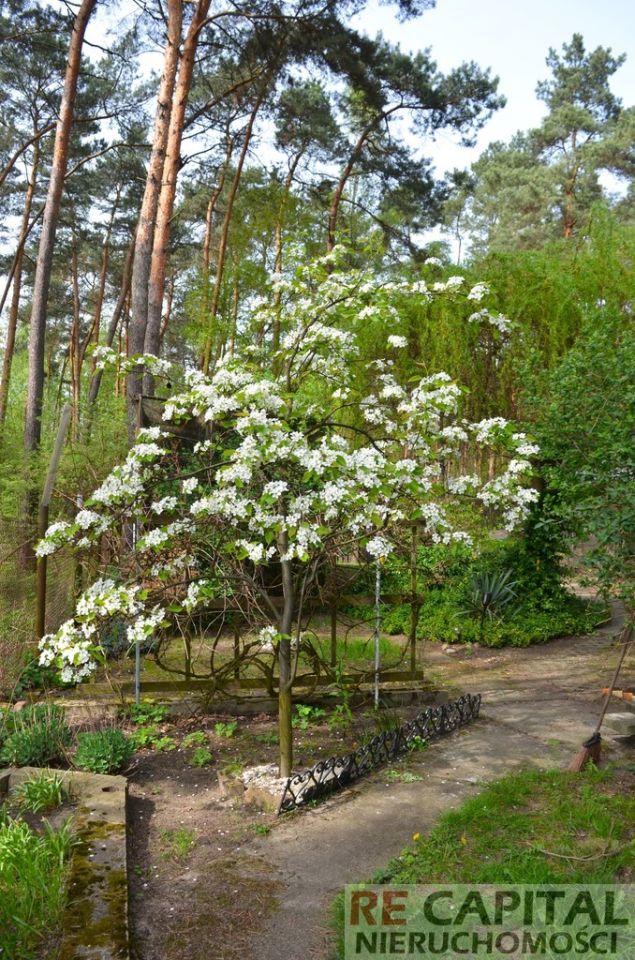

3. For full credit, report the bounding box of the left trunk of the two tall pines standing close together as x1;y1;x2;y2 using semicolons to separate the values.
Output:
126;0;183;442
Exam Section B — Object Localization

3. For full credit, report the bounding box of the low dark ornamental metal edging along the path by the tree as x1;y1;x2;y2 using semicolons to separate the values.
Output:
278;693;481;815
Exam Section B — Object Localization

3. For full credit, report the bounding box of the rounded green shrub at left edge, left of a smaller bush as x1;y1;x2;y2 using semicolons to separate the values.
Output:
0;704;71;767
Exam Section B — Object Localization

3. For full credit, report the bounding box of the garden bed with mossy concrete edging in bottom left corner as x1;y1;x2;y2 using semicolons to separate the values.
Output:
0;767;129;960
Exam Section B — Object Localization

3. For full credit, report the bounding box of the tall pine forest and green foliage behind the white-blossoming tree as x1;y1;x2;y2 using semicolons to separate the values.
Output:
0;0;635;690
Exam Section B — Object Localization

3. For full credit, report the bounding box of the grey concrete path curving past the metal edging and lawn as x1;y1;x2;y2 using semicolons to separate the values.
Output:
246;612;632;960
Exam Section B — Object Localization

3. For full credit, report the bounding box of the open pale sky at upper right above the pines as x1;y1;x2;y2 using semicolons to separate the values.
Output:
355;0;635;173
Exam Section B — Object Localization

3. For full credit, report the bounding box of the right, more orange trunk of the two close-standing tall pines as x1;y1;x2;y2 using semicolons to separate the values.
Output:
143;0;211;394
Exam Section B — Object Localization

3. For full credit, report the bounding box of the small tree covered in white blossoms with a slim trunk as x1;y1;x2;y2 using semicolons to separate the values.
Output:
38;252;535;776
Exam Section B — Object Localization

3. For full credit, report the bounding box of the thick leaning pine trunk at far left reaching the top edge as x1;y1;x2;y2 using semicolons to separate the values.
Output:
21;0;97;566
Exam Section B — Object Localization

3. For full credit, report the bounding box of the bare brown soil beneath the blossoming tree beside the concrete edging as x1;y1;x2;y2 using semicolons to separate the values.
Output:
128;707;402;960
